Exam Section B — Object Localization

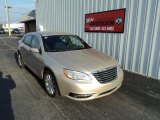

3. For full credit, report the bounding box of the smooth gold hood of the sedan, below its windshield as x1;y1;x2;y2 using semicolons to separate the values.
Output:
47;48;117;72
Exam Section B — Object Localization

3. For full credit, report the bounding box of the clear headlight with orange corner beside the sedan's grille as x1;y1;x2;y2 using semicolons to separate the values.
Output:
63;69;91;80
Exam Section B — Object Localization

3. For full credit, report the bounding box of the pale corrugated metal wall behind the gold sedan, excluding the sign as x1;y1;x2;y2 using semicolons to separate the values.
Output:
36;0;160;79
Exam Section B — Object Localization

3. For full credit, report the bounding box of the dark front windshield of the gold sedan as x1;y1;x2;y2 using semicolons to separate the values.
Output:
42;35;91;52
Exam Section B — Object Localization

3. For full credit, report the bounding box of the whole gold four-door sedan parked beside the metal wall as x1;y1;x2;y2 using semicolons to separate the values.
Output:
17;32;123;101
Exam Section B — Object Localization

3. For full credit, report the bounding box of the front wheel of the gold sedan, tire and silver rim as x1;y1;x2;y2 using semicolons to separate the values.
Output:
43;70;58;97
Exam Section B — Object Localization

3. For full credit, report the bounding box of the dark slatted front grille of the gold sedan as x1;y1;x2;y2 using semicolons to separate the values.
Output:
92;67;117;83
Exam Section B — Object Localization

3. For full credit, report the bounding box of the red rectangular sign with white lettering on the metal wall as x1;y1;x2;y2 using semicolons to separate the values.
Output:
85;9;126;33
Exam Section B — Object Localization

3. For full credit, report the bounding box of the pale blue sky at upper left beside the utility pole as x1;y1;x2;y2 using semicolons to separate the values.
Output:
0;0;35;24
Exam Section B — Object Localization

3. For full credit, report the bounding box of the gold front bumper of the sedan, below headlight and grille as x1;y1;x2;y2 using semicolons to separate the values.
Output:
60;70;123;101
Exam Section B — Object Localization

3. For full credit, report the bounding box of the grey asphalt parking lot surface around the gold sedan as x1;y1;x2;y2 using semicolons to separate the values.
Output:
0;35;160;120
